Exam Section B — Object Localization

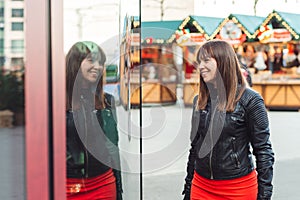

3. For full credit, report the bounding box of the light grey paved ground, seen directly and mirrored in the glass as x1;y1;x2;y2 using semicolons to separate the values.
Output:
0;105;300;200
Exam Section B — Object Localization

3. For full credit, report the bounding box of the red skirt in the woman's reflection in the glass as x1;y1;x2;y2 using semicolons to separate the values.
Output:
66;169;117;200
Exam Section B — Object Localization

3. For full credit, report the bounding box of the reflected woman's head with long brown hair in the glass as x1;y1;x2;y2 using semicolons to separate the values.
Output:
66;41;106;110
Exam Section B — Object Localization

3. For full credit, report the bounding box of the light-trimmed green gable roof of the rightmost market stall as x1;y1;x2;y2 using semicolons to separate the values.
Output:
256;10;300;40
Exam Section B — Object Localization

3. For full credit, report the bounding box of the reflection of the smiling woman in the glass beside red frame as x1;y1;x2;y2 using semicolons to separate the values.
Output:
66;41;122;200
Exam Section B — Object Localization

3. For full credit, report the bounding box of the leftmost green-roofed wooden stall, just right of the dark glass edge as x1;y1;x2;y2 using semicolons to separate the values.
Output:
141;21;181;105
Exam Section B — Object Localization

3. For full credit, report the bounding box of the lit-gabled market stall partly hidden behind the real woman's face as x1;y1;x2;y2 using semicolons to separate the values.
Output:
176;15;223;106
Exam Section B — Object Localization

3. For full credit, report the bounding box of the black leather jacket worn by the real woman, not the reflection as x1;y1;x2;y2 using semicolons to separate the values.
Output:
184;88;274;199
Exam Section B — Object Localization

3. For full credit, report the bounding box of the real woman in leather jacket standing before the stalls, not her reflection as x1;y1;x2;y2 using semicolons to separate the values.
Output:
183;40;274;200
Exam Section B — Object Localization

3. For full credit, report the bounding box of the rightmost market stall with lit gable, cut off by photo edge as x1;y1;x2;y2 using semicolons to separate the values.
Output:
253;11;300;110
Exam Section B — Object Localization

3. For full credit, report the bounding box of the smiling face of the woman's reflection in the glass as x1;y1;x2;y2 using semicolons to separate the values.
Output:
80;56;103;83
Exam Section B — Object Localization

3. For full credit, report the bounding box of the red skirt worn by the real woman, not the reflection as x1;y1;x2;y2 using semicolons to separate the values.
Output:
191;170;258;200
